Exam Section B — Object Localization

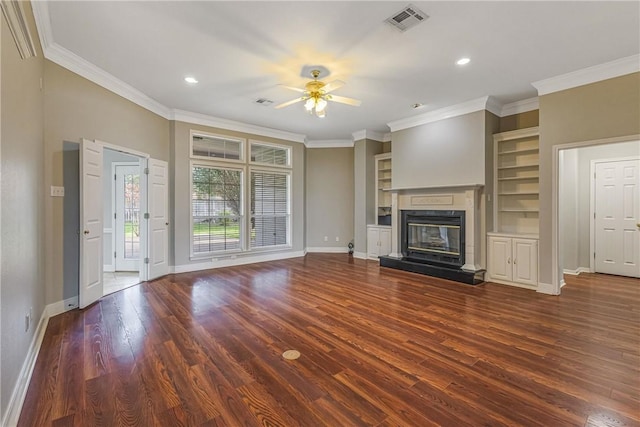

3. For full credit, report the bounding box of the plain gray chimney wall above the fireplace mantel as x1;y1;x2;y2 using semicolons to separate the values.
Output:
391;111;486;189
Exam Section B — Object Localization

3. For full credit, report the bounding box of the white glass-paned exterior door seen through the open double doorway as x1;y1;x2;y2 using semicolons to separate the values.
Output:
113;163;141;271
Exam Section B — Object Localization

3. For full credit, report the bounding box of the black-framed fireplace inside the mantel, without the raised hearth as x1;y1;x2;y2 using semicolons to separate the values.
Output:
400;210;465;268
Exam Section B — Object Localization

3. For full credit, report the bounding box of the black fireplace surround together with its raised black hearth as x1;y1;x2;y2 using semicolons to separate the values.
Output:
380;210;484;285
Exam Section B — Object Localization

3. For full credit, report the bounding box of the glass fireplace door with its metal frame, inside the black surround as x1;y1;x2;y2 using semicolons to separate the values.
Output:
407;222;460;257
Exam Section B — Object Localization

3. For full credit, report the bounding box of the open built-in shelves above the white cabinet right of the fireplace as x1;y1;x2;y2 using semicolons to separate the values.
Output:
493;127;540;234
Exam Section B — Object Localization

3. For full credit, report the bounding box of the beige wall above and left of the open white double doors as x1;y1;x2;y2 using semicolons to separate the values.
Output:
44;60;169;304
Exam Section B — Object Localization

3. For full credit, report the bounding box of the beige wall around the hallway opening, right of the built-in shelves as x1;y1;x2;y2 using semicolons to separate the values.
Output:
539;73;640;284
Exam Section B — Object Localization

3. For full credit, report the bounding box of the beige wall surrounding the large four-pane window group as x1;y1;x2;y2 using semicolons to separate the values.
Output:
169;122;305;268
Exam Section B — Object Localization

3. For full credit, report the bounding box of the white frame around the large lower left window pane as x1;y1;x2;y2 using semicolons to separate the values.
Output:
189;160;247;260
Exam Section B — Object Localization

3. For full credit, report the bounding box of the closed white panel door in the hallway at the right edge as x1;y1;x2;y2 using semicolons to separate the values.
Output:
594;160;640;277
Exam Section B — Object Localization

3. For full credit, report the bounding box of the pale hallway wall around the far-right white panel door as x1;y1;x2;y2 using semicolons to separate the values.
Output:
558;141;640;271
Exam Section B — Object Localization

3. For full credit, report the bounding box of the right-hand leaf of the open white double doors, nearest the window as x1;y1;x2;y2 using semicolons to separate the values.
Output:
147;159;169;280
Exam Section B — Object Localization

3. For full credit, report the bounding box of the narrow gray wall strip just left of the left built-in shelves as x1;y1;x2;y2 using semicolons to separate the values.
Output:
353;139;383;256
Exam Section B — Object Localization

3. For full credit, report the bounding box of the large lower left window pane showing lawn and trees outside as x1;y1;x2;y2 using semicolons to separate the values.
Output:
191;165;243;255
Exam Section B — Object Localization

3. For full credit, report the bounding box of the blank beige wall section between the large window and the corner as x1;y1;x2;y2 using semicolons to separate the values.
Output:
306;148;356;252
